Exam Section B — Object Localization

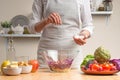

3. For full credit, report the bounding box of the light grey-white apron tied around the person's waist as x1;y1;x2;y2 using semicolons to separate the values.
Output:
38;0;82;68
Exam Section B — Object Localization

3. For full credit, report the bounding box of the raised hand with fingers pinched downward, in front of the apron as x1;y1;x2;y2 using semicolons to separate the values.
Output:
47;12;62;25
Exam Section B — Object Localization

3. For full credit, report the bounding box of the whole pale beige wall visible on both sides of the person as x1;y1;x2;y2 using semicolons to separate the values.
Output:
0;0;120;63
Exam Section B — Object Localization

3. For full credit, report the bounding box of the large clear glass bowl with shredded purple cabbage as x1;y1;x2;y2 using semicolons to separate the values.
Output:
43;50;79;72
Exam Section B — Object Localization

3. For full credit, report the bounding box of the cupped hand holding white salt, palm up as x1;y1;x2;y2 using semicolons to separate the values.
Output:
73;35;86;45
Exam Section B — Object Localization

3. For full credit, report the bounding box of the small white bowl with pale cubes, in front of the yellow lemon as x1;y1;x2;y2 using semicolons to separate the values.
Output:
3;67;22;76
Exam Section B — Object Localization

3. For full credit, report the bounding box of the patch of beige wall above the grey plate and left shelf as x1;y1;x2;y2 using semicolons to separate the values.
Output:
0;0;33;21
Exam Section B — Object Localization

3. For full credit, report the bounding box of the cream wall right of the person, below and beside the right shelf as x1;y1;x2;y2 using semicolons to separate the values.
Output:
83;0;120;58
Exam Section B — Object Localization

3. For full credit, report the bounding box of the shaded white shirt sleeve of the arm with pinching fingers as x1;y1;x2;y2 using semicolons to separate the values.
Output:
28;0;43;33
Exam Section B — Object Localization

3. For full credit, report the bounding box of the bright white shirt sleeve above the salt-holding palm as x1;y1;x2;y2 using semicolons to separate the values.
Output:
81;0;94;36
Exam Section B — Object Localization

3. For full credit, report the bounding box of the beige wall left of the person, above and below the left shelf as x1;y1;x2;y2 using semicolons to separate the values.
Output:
0;0;35;63
